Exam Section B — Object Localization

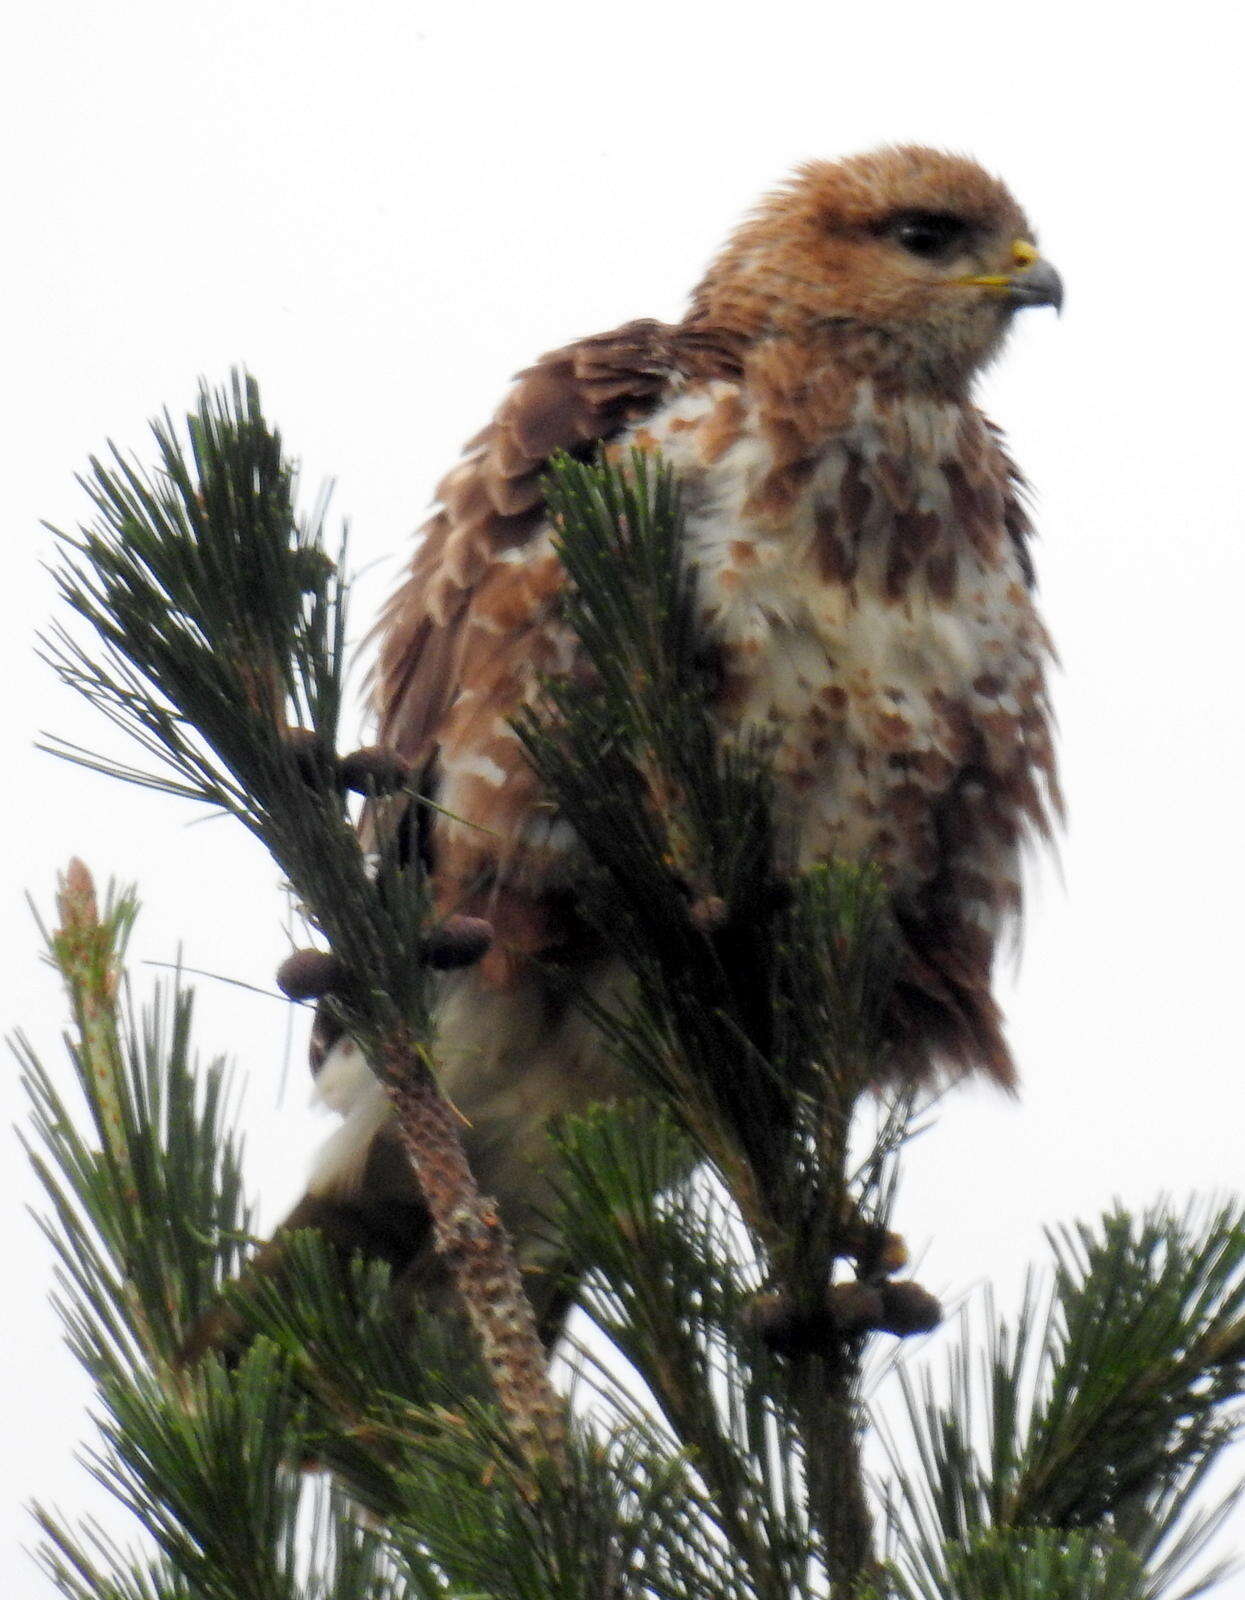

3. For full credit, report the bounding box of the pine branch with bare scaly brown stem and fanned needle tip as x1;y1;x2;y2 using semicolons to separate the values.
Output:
45;376;562;1459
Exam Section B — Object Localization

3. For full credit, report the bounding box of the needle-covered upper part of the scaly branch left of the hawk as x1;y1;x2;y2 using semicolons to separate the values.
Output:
45;374;427;1038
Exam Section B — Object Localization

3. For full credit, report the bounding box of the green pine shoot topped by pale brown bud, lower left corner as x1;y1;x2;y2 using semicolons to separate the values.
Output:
16;867;395;1600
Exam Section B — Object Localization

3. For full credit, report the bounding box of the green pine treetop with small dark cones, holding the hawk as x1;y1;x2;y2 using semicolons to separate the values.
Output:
18;379;1245;1600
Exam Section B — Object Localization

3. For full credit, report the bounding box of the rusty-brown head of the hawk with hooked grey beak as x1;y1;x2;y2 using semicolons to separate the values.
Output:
693;146;1063;389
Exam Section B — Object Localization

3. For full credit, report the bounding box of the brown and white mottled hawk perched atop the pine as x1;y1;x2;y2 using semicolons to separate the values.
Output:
290;147;1063;1328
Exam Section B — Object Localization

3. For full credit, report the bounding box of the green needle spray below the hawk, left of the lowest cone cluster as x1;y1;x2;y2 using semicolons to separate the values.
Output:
547;1107;826;1597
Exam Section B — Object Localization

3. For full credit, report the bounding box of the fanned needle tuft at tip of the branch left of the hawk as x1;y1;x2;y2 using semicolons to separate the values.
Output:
48;373;346;806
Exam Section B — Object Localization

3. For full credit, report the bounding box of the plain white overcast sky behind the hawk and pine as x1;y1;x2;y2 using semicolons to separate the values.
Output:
0;0;1245;1600
